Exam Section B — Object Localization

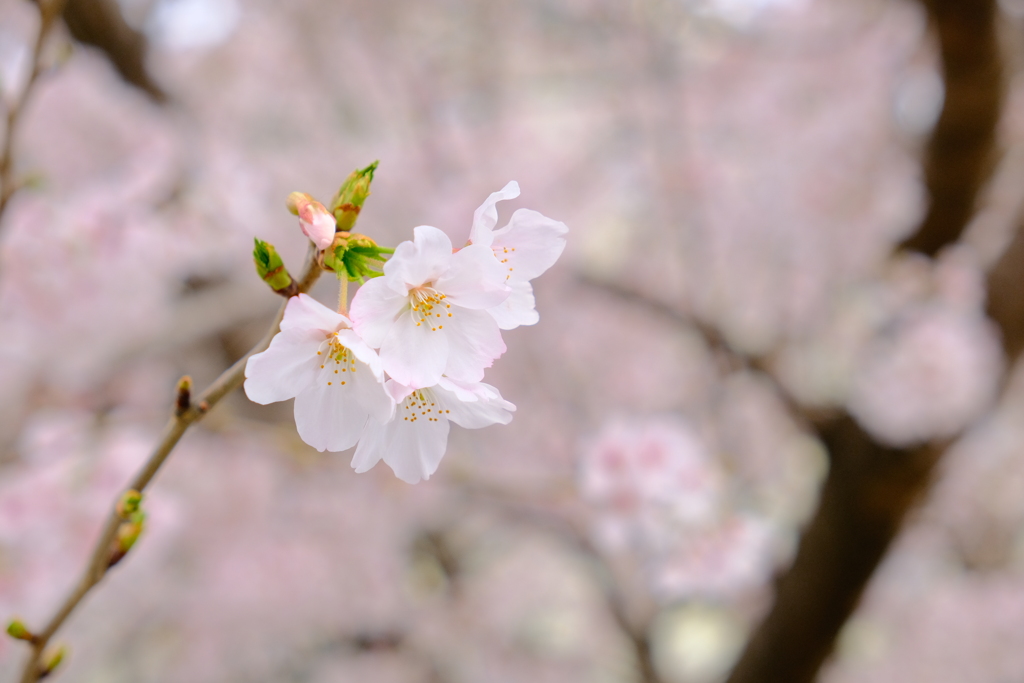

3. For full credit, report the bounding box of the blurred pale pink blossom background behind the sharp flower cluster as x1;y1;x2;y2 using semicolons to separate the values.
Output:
0;0;1024;683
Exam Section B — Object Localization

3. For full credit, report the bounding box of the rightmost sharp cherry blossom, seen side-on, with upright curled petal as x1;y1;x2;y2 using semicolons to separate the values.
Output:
470;180;568;330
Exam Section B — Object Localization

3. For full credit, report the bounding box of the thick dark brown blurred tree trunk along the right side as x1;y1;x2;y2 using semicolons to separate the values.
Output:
728;0;1003;683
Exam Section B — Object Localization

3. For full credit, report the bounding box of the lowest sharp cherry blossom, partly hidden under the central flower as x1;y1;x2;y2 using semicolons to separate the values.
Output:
352;377;515;483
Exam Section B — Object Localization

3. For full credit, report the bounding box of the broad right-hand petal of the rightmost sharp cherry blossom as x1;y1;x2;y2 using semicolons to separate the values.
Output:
490;209;568;282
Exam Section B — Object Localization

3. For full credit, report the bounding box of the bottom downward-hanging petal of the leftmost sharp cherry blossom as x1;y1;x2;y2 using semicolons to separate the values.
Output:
295;374;369;452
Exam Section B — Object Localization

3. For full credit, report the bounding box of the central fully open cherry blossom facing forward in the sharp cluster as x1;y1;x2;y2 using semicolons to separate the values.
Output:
351;225;509;388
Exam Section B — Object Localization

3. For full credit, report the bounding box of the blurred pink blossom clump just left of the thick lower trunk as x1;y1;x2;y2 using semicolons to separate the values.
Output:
579;419;773;600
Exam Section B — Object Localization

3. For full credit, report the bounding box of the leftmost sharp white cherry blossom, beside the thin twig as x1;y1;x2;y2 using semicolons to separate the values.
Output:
245;294;394;451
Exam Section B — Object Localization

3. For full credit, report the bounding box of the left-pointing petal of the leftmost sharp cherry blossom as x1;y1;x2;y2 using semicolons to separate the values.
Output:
245;330;325;405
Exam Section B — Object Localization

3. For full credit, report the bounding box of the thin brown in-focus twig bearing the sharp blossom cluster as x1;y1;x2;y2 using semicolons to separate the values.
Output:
20;247;322;683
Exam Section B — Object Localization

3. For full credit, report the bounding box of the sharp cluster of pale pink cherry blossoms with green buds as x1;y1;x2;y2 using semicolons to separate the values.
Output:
245;164;566;483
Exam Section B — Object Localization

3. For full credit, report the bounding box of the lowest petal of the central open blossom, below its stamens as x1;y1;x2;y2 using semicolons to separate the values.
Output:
380;310;448;388
